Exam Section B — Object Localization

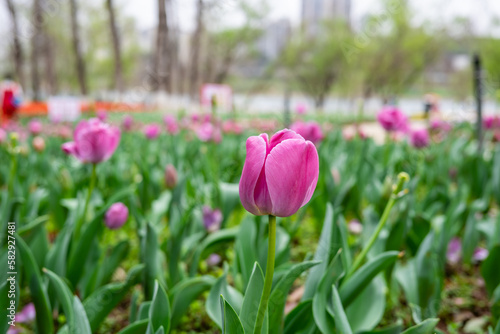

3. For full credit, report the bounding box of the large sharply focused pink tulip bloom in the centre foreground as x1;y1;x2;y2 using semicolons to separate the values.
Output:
239;129;319;217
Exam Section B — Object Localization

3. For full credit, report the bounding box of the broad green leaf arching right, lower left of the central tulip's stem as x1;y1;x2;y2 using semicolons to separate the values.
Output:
171;276;215;328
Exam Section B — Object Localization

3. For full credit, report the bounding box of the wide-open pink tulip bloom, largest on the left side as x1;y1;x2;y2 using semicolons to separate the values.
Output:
62;118;121;164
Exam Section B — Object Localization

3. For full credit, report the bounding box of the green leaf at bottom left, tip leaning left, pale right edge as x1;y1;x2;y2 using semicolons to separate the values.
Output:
43;269;92;334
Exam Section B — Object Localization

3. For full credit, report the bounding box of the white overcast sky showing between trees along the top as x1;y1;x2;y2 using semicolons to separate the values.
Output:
0;0;500;34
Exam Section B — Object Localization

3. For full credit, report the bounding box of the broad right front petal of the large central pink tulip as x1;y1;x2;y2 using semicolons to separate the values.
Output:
265;139;319;217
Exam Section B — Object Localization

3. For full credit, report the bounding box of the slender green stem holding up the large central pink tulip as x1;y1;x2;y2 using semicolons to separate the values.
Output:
254;215;276;334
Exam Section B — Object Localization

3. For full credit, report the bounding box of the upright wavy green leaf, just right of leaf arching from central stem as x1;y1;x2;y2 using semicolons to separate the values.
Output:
312;250;344;334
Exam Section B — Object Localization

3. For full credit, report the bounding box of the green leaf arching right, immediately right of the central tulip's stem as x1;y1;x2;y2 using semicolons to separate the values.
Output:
269;261;321;333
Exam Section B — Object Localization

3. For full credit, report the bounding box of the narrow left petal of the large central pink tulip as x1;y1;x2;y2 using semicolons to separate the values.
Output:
239;134;268;216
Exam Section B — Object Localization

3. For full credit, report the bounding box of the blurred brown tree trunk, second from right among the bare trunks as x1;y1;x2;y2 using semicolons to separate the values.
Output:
153;0;170;91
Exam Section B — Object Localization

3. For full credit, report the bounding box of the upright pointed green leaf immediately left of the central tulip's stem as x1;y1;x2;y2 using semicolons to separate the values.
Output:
240;262;264;333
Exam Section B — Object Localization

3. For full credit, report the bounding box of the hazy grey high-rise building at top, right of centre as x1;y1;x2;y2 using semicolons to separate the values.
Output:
302;0;351;36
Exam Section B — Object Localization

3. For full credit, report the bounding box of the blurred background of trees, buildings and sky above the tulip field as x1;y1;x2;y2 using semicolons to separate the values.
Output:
0;0;500;118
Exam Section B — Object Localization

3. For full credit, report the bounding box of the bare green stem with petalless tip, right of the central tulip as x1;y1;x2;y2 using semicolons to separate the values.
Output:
345;173;409;280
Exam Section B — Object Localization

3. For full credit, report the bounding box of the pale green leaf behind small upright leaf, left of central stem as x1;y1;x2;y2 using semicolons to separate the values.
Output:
205;271;243;328
